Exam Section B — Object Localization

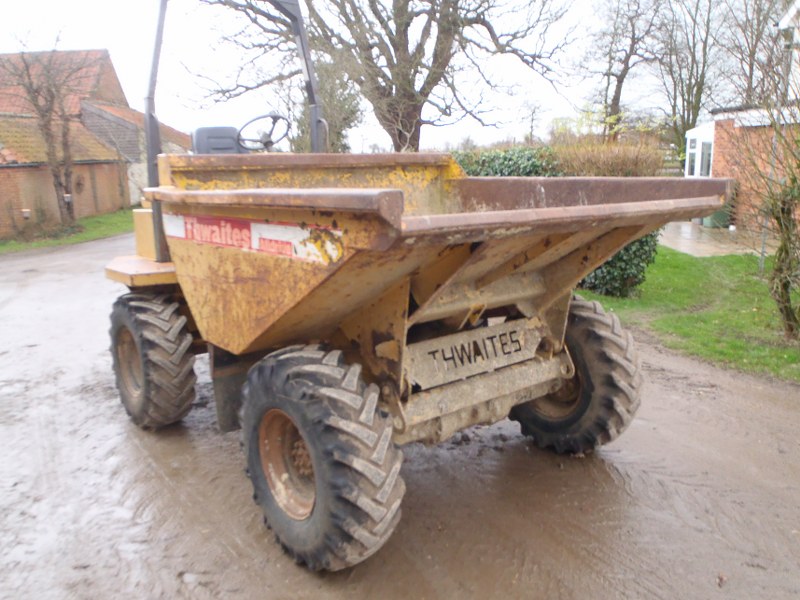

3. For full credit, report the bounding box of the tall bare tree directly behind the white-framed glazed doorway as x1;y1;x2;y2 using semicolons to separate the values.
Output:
656;0;721;154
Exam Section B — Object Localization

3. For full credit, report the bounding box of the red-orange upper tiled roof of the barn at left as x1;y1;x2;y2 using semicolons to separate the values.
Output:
0;50;128;114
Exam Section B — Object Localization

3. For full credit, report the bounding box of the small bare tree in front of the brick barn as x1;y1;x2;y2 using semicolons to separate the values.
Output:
0;50;96;225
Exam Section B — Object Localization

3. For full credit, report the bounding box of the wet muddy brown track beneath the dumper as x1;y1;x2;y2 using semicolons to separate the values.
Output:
0;236;800;599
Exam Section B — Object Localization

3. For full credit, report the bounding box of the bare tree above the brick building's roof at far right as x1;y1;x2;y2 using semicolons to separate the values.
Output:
718;0;790;106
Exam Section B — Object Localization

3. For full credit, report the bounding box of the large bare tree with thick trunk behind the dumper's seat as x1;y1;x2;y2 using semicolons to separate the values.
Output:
203;0;567;151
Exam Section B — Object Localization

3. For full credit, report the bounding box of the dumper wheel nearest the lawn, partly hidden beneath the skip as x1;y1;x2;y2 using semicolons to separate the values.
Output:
509;297;642;453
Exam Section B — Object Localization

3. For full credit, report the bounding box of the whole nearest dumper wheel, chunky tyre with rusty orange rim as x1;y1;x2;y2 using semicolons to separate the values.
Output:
241;346;405;571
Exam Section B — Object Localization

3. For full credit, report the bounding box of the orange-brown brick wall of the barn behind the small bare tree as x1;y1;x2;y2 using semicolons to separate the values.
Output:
0;163;130;239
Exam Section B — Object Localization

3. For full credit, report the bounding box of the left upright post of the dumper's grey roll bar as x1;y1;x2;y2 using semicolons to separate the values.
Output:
144;0;170;262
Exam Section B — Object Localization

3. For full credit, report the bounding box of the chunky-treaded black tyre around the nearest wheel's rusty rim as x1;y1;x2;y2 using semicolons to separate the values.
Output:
241;345;405;571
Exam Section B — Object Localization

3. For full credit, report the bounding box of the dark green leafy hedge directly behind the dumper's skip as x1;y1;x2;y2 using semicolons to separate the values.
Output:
453;146;658;297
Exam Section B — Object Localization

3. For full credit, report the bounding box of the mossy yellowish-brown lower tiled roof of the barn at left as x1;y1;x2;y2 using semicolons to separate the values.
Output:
0;115;119;165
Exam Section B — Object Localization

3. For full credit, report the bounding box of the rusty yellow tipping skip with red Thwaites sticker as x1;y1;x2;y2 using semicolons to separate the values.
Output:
108;154;731;441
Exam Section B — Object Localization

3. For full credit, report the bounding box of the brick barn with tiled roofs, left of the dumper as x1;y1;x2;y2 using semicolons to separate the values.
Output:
0;50;191;239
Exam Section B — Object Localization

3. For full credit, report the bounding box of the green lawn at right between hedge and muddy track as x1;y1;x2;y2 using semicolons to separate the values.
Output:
581;246;800;381
